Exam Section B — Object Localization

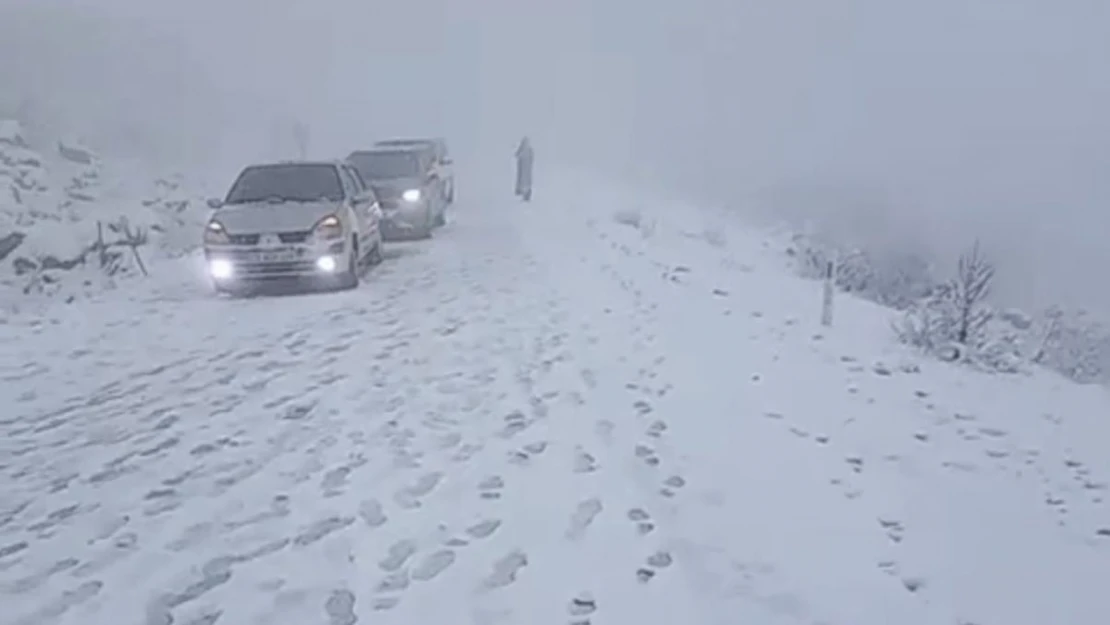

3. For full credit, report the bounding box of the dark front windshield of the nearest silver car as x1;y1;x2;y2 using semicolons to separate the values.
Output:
226;163;343;204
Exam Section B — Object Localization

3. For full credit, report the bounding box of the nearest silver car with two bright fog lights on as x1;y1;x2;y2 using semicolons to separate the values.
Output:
204;161;382;293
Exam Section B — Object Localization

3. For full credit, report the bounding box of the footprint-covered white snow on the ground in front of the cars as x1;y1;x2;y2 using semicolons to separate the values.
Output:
0;167;1110;625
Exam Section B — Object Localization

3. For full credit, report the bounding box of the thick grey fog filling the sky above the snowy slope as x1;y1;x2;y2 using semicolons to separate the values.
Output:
0;0;1110;314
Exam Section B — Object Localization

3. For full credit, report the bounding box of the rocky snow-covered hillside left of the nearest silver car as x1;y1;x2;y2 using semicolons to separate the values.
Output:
0;120;205;308
